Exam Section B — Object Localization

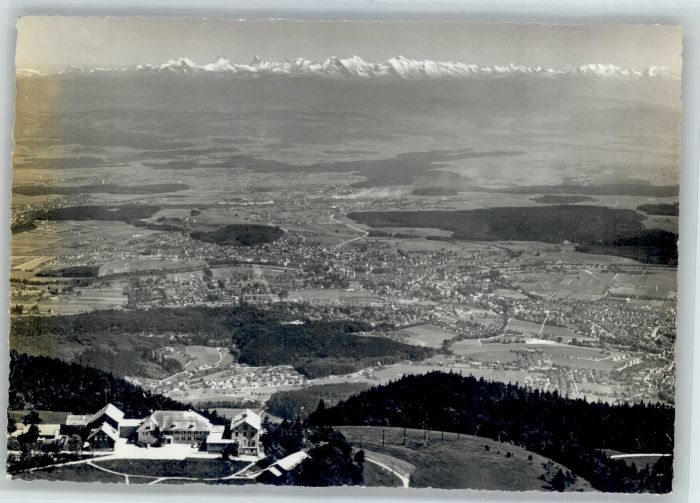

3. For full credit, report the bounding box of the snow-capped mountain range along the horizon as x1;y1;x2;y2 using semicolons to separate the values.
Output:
17;56;679;79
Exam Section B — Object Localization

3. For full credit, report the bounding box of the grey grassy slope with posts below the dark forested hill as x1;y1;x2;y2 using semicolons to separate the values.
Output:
335;426;593;491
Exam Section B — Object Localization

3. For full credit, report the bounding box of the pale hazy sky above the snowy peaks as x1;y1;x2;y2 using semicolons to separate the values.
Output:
17;17;681;72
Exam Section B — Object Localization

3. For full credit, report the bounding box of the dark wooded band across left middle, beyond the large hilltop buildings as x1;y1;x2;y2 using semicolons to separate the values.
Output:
10;304;433;377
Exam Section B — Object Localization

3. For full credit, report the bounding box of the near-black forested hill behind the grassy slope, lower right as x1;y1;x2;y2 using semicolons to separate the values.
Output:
310;372;674;493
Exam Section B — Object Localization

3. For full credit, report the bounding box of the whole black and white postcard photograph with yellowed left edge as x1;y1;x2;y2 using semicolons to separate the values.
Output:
6;16;683;494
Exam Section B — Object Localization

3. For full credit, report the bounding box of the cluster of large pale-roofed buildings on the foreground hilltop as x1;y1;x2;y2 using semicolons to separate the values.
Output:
13;404;262;456
